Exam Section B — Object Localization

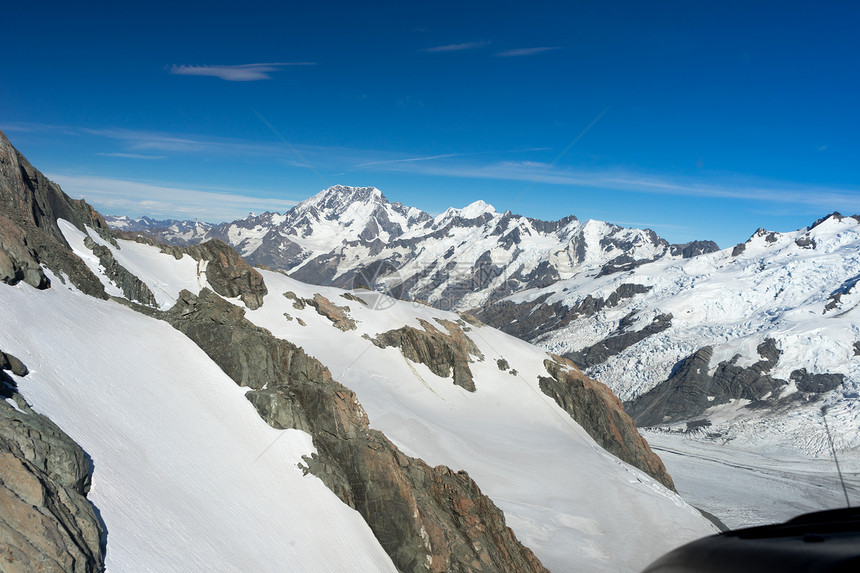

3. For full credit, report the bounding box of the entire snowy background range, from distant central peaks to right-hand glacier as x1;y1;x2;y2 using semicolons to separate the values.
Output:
106;187;860;526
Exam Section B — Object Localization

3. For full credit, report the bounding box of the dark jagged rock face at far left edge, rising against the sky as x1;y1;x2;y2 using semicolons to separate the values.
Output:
0;127;110;292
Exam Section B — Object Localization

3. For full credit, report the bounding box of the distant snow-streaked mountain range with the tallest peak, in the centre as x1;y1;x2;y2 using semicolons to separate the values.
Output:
109;186;717;310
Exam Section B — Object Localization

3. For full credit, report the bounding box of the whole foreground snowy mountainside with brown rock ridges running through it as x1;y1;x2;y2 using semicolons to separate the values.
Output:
0;134;714;571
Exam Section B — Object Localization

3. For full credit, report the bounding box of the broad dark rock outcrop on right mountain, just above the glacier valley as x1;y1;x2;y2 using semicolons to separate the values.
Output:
625;338;788;426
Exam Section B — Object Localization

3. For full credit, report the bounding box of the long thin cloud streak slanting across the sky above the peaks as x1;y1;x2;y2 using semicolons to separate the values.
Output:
23;122;860;214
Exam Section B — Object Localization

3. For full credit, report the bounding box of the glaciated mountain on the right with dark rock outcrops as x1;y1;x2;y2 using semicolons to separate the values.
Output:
480;213;860;457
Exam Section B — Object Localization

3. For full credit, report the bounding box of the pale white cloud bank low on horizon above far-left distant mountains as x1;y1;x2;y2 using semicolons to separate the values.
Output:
46;173;297;223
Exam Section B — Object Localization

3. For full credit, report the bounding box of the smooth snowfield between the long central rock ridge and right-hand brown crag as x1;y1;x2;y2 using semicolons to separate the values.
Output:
50;221;714;572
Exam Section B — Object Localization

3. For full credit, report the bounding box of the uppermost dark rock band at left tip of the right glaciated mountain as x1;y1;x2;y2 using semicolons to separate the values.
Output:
473;283;652;340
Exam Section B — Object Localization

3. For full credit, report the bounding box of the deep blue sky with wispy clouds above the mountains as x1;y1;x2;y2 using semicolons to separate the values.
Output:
0;1;860;247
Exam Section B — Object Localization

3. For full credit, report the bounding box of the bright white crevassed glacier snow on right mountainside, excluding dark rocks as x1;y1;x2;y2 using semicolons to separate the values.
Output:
507;215;860;457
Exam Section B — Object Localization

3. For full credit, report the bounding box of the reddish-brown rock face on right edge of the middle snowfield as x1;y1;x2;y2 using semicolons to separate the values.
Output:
538;356;675;491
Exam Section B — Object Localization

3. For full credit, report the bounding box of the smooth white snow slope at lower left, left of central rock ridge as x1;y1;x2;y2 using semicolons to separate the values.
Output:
0;277;394;572
